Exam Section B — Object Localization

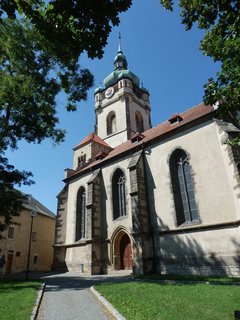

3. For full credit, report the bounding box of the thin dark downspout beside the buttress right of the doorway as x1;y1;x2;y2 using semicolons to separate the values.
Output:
142;143;157;273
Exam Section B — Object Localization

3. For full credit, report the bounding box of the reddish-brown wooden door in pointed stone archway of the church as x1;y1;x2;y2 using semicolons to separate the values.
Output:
113;230;132;270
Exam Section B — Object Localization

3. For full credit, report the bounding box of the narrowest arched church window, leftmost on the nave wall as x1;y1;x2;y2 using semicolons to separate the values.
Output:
75;187;86;241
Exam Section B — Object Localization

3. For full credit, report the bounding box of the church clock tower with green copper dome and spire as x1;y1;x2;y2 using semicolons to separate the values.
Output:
95;45;151;148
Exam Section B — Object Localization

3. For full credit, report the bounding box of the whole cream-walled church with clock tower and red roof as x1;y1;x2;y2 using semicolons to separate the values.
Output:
53;46;240;276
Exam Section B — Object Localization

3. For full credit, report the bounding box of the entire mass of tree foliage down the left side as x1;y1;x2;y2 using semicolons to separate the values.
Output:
0;0;132;224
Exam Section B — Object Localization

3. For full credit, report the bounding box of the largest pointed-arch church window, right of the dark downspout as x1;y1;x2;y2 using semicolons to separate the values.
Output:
170;149;199;225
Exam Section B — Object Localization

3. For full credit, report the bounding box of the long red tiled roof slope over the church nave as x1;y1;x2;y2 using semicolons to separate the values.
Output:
65;103;214;181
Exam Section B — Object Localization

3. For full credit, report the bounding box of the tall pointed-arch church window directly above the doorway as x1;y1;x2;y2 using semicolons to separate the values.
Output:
112;169;126;219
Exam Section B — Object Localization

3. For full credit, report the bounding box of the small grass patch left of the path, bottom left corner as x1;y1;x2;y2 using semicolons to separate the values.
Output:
0;280;41;320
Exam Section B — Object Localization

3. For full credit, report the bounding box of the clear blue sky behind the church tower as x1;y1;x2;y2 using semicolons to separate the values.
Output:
7;0;218;213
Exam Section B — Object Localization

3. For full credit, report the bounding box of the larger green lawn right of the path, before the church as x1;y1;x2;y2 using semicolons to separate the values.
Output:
96;281;240;320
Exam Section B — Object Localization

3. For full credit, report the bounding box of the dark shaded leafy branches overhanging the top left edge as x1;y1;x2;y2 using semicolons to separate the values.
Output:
0;0;132;61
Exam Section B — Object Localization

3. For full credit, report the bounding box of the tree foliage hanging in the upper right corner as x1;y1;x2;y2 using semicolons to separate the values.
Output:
160;0;240;117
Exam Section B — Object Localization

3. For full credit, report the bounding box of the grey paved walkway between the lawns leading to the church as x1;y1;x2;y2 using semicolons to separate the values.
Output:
37;273;129;320
